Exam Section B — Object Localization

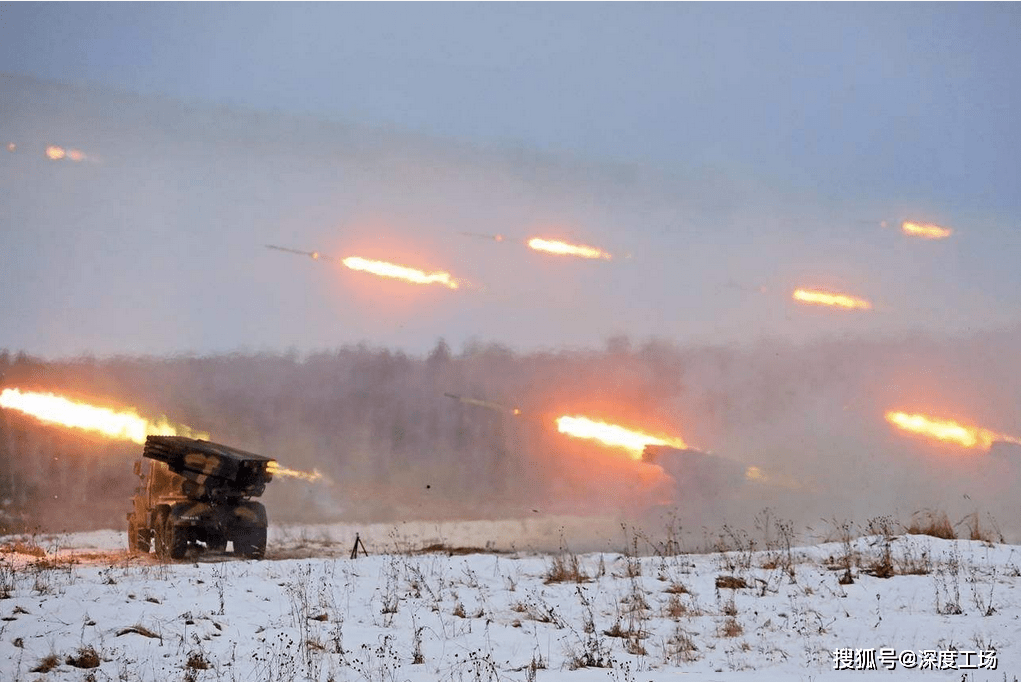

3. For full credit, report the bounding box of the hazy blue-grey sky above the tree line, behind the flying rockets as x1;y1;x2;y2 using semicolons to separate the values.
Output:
0;3;1021;355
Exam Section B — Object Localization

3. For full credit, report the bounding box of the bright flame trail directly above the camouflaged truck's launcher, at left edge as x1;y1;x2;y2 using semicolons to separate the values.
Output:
0;388;209;443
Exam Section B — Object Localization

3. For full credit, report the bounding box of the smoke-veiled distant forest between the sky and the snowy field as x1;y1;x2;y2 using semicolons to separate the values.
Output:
0;329;1021;532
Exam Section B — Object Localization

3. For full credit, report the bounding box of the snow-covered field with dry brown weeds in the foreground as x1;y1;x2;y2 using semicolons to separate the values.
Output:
0;520;1021;682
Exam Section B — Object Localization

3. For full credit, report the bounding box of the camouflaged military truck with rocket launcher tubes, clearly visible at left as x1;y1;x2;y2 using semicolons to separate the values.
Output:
128;436;274;561
